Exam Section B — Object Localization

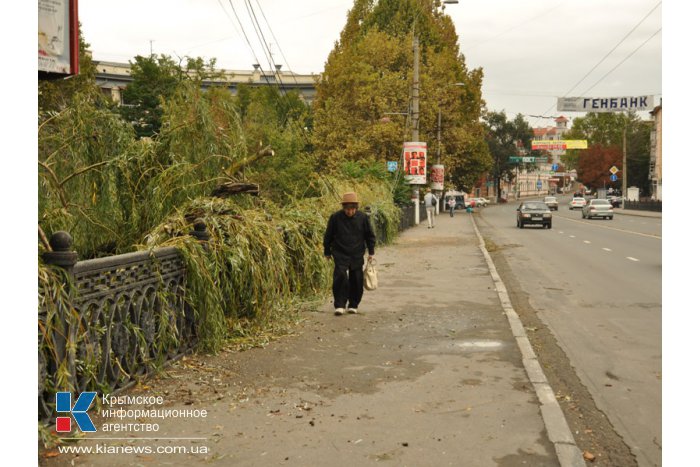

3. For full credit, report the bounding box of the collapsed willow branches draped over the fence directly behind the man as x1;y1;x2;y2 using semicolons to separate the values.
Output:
144;177;399;351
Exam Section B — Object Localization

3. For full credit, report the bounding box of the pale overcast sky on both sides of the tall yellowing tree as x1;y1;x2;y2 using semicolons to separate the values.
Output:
79;0;663;126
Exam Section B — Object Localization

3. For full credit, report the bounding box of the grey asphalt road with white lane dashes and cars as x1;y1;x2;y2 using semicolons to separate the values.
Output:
477;198;661;466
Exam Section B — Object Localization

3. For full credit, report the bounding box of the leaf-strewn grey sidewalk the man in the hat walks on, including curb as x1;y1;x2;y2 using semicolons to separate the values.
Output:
42;210;584;467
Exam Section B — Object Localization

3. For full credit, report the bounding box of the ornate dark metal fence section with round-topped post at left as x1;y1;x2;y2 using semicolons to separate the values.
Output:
39;233;196;418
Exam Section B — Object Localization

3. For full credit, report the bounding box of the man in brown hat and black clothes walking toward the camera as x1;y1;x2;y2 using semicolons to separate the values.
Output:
323;192;376;316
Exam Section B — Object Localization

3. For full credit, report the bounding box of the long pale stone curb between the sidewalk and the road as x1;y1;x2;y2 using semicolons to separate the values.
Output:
471;217;586;467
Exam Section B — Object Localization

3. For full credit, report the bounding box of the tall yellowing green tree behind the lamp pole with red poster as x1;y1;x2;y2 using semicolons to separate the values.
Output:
313;0;491;189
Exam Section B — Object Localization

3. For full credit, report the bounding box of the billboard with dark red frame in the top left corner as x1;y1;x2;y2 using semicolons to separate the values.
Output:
38;0;80;76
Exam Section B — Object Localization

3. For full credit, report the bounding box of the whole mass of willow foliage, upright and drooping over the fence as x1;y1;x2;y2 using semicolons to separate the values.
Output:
39;45;406;358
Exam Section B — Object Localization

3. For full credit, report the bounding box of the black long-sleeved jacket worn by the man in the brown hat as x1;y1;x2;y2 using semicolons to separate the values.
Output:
323;209;376;266
